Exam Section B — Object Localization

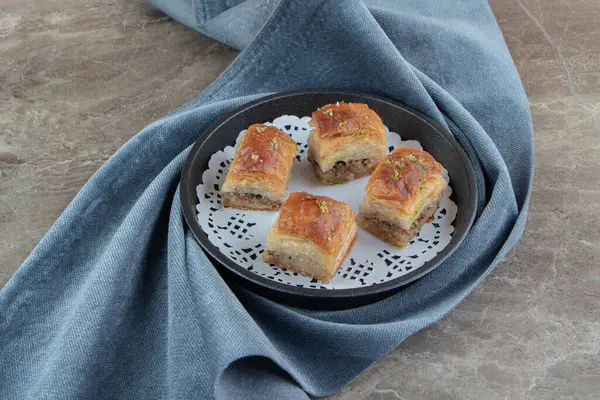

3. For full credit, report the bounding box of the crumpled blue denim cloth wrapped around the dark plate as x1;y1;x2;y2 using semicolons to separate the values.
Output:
0;0;533;400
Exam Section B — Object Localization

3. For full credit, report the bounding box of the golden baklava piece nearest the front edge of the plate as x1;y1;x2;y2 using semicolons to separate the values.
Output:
263;192;358;282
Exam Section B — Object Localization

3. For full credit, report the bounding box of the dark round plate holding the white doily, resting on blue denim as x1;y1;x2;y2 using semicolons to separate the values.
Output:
181;89;477;309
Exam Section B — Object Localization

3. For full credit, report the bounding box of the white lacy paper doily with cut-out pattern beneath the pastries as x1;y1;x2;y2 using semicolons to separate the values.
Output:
196;115;457;289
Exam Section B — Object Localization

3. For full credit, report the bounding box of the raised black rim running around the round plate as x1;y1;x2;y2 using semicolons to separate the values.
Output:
179;89;477;299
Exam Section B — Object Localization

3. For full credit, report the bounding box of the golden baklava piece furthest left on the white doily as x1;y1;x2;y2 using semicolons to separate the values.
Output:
221;124;297;210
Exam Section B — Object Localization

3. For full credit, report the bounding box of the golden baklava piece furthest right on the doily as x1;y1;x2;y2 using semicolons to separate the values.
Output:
357;147;448;247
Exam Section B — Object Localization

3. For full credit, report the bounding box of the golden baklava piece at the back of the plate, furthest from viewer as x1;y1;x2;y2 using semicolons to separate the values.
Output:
308;102;387;184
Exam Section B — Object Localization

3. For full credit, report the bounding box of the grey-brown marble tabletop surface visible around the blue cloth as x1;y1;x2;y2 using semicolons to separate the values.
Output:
0;0;600;400
